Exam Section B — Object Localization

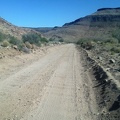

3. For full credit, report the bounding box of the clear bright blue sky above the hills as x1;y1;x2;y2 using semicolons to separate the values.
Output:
0;0;120;27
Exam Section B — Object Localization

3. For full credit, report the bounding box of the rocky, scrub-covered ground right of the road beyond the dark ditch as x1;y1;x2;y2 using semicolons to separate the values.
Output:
77;35;120;88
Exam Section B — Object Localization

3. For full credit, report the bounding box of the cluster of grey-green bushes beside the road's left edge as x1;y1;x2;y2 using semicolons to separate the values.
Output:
0;33;48;53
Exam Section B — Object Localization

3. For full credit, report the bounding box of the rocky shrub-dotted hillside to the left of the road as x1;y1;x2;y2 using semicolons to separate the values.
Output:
0;18;48;52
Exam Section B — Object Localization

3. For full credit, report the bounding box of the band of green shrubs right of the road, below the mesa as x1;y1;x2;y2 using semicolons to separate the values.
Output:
77;32;120;54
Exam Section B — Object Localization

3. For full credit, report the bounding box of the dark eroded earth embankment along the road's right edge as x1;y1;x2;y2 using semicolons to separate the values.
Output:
78;47;120;120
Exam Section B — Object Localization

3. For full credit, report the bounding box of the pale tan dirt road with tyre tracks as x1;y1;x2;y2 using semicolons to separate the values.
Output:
0;44;97;120
